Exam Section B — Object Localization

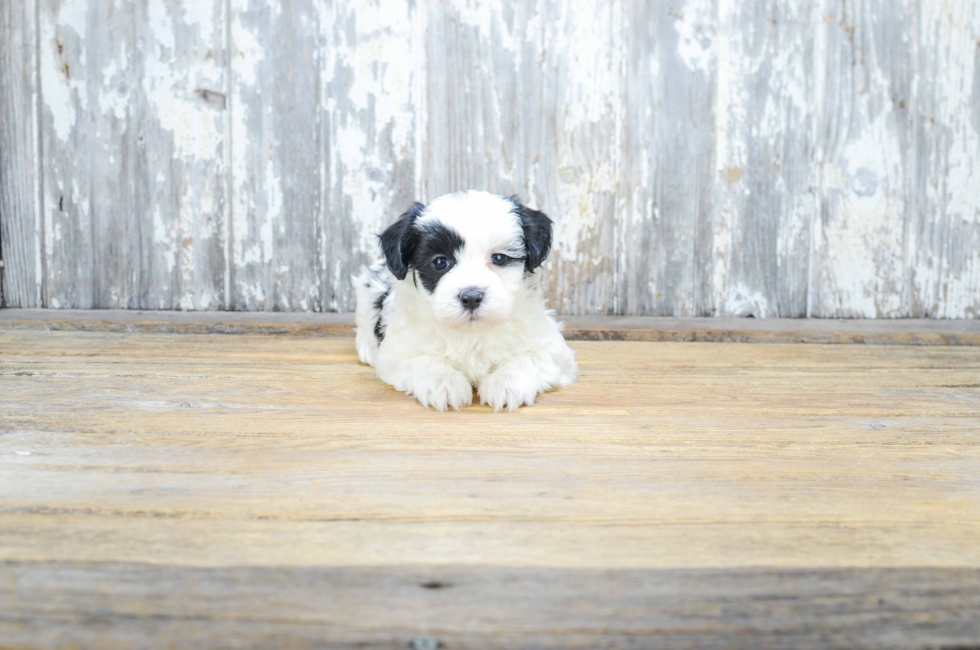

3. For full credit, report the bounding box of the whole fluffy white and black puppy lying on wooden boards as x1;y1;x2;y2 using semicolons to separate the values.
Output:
354;190;578;411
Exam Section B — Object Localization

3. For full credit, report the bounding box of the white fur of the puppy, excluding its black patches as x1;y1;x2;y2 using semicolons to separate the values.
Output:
354;191;578;411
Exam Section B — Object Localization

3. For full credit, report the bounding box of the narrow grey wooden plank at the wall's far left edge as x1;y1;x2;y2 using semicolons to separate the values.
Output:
0;0;43;307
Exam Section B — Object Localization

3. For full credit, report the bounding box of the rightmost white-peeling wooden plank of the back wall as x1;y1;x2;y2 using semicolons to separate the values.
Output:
909;2;980;318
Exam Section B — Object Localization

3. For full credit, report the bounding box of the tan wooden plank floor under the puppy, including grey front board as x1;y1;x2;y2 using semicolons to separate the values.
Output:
0;330;980;649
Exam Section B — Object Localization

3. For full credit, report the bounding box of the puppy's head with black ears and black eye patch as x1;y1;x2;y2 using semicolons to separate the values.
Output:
381;191;551;329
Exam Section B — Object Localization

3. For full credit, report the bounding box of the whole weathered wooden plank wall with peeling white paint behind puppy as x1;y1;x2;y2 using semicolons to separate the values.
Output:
0;0;980;318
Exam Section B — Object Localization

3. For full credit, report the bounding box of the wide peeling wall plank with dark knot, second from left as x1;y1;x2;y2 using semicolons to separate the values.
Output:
40;0;225;309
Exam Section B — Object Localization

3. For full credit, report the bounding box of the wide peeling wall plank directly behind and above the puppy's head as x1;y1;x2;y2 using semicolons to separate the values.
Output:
422;0;624;314
